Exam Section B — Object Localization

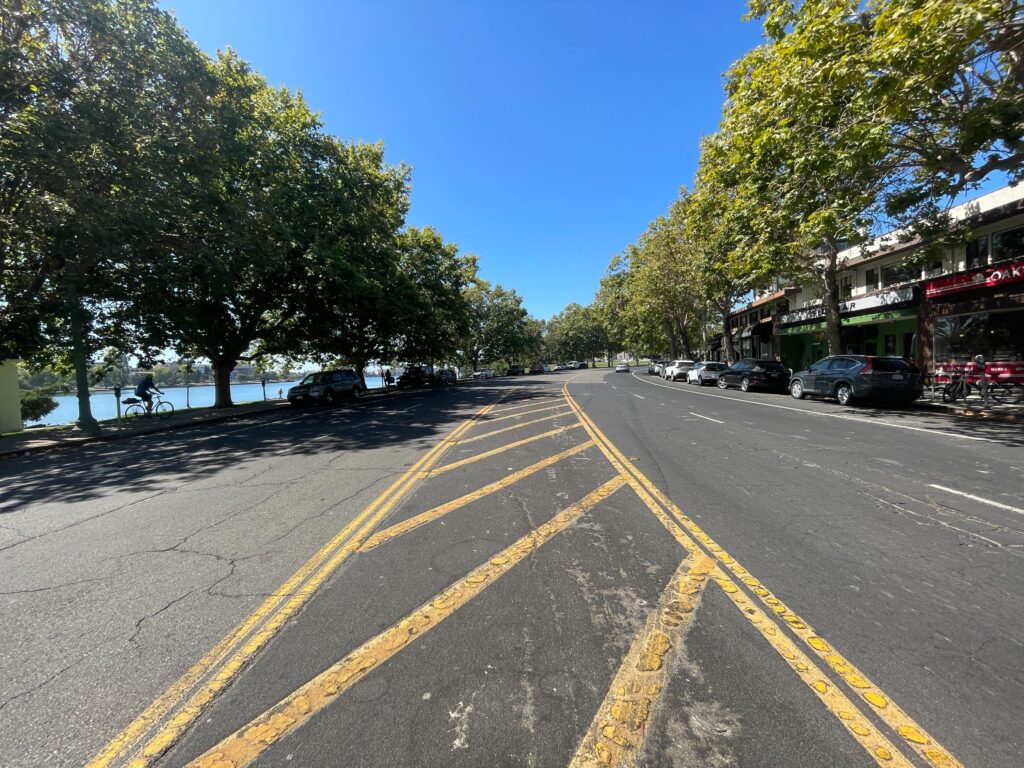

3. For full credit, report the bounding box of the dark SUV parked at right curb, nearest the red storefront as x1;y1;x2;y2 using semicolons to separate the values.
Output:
790;354;924;406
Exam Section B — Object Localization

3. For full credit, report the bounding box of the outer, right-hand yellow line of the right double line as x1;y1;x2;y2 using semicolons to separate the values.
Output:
563;386;963;768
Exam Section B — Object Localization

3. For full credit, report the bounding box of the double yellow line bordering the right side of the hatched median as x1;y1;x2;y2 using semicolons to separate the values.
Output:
562;385;963;768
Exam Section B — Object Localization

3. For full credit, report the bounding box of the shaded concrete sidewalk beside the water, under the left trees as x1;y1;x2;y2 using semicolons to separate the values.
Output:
0;388;405;461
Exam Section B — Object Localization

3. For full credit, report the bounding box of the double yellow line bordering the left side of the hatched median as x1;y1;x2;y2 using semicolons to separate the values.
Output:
87;397;502;768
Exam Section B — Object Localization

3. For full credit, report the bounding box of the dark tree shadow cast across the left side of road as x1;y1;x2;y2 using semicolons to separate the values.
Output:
0;380;561;515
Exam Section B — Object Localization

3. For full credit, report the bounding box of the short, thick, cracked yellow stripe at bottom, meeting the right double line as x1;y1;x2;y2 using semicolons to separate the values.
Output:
569;557;715;768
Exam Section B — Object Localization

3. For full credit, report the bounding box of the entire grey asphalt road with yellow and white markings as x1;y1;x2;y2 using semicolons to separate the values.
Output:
0;371;1024;768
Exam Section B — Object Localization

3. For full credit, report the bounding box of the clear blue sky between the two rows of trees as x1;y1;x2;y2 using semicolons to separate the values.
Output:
162;0;761;318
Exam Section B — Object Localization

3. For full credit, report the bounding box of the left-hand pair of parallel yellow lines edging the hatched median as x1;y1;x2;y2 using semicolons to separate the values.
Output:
94;398;501;768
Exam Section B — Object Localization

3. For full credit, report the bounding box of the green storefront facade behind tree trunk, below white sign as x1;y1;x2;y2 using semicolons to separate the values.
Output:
775;306;918;371
